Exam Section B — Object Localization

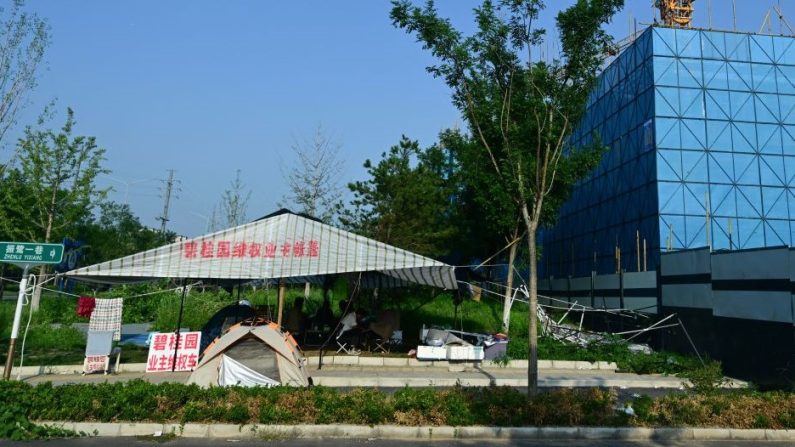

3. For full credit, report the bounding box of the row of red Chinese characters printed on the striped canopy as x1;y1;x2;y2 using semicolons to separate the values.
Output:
182;239;320;259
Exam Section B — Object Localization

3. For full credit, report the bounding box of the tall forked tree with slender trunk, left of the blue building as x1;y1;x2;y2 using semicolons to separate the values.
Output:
391;0;624;394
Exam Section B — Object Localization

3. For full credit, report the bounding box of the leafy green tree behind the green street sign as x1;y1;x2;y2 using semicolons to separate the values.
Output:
0;109;108;309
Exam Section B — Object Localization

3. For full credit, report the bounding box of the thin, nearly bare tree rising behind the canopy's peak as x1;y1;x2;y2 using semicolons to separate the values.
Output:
283;125;343;223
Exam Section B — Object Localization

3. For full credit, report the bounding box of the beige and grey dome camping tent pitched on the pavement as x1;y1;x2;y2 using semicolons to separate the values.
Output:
188;322;309;387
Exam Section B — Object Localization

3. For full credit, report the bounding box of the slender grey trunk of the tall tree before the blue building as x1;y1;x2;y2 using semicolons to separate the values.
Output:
522;203;541;397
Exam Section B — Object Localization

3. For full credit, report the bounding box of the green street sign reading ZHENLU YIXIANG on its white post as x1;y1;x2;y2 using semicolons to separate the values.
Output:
0;242;63;380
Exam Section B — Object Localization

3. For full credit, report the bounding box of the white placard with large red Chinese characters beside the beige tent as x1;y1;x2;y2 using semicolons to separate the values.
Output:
146;332;202;372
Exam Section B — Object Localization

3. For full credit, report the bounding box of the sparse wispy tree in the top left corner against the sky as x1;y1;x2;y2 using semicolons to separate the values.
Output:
0;0;50;160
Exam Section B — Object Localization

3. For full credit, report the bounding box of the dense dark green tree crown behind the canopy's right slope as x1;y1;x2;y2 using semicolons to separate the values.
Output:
340;136;457;257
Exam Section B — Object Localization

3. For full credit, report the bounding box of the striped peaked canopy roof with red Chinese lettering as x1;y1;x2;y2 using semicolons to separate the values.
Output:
65;212;457;289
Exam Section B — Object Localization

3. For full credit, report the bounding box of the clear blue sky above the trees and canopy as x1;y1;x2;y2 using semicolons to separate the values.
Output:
7;0;795;236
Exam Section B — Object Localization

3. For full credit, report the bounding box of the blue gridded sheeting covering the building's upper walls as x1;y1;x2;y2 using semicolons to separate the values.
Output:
541;27;795;277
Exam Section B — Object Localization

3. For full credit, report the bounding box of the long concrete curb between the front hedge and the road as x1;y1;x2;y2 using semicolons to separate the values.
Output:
38;421;795;441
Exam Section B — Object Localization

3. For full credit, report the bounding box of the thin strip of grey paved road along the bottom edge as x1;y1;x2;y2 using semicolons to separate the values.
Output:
3;438;790;447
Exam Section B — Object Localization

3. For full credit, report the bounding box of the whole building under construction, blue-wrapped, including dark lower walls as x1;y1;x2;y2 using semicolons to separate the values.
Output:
539;6;795;385
